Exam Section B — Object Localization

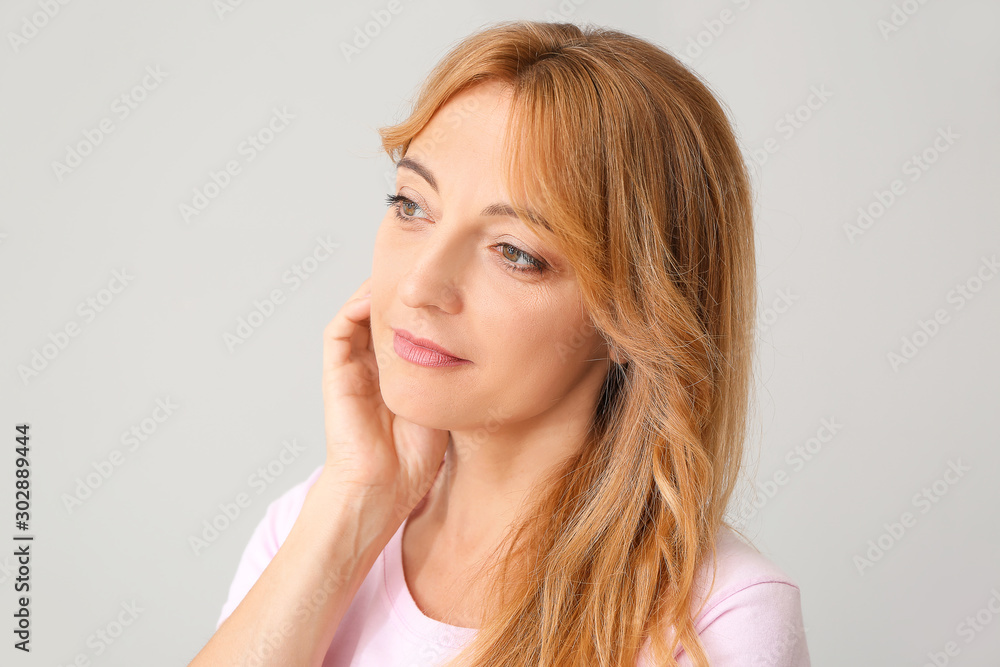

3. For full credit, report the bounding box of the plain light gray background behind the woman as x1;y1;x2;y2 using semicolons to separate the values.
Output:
0;0;1000;666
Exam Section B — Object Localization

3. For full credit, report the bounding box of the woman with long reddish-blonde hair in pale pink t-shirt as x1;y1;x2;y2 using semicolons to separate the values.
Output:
191;22;809;667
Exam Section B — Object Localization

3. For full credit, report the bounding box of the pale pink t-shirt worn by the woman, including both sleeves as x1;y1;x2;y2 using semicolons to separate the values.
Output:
216;466;810;667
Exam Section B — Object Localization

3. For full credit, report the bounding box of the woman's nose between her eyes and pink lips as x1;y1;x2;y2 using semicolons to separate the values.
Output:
398;227;471;314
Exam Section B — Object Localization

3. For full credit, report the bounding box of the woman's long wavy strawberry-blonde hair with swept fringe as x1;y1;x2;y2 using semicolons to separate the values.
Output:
378;21;756;667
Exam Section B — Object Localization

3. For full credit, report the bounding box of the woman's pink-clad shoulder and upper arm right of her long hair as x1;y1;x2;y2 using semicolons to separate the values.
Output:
680;527;810;667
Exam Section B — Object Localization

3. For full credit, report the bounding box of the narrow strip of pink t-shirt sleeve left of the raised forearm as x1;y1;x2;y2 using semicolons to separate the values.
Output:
215;466;323;630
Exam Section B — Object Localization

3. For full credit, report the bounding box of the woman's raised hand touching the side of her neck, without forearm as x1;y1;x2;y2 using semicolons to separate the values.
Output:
322;278;449;529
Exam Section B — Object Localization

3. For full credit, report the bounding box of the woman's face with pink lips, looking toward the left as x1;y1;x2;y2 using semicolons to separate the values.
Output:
371;82;608;433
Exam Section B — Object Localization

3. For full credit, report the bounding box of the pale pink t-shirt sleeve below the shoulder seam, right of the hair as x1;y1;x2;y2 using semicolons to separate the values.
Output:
679;581;811;667
